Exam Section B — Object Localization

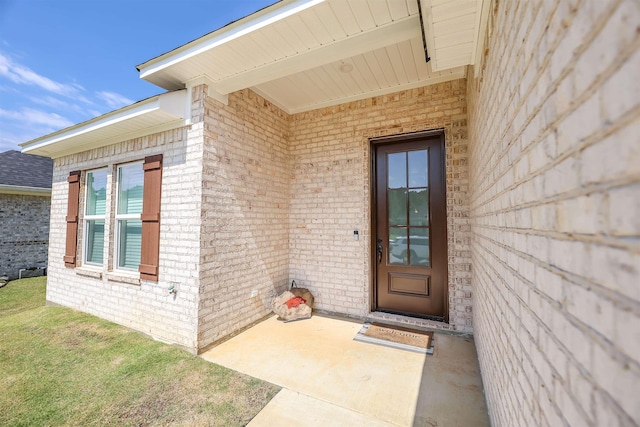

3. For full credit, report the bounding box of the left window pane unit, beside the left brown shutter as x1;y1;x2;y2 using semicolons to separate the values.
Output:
84;169;107;265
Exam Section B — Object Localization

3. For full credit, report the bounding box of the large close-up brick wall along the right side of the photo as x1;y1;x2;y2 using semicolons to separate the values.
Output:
467;0;640;426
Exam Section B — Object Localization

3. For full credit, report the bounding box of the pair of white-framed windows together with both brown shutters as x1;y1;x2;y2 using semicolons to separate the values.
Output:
64;154;162;282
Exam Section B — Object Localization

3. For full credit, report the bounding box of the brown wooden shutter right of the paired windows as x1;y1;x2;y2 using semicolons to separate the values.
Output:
138;154;162;282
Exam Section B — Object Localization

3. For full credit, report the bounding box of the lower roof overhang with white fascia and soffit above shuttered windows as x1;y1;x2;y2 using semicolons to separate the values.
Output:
20;90;189;158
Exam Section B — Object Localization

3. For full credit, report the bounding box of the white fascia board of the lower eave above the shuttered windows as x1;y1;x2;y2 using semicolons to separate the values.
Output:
20;89;188;153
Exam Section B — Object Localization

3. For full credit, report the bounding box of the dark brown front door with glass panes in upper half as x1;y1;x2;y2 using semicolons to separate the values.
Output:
374;132;447;320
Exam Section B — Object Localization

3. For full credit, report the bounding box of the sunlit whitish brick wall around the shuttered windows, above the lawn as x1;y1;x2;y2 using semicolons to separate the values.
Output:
47;124;202;350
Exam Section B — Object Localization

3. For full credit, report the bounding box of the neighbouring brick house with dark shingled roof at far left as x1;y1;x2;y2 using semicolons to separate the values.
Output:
0;150;53;279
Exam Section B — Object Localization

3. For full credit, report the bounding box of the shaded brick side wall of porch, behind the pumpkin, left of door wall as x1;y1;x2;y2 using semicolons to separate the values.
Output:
198;87;290;348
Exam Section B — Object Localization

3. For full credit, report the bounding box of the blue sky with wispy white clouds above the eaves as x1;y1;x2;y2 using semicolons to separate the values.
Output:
0;0;275;152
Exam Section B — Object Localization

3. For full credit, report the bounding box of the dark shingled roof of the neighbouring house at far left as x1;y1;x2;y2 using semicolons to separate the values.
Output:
0;150;53;188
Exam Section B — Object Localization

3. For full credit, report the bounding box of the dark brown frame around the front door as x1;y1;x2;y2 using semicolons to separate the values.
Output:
369;128;449;323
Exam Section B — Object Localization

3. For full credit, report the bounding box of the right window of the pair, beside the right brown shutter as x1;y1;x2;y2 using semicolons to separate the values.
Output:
115;163;144;271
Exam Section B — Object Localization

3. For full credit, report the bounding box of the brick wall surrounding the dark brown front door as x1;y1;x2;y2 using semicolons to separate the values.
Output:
289;80;472;331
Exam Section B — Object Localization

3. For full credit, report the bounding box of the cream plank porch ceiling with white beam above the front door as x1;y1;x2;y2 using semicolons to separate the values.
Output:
138;0;489;113
